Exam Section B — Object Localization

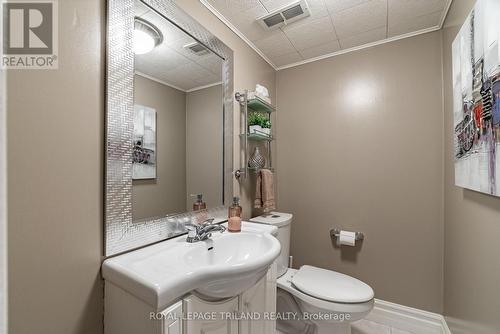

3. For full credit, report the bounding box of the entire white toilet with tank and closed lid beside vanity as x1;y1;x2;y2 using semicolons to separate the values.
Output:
250;212;374;334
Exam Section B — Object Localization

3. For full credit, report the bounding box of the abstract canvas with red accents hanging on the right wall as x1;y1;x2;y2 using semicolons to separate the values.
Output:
452;0;500;196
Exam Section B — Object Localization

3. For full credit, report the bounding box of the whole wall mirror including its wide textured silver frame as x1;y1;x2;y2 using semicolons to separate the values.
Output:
105;0;233;256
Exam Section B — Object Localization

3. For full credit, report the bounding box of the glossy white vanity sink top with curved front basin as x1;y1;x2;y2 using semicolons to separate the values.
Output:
102;222;281;309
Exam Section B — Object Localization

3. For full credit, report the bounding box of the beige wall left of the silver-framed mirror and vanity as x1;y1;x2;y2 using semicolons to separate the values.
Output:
7;0;105;334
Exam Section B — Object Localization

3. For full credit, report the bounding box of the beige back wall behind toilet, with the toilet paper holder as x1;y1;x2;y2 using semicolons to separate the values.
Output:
277;32;443;312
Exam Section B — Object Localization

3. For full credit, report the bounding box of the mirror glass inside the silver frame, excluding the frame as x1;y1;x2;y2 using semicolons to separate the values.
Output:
132;0;224;221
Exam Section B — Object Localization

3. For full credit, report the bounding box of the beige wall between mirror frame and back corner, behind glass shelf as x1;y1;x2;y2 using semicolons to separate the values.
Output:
176;0;276;217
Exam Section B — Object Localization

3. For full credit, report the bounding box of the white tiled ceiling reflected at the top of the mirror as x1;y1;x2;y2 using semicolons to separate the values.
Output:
135;1;222;91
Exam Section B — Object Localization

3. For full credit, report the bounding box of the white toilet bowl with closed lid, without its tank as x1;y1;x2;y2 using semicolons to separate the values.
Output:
277;266;373;334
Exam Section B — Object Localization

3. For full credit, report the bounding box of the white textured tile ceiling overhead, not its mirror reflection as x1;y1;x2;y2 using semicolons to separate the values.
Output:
200;0;452;68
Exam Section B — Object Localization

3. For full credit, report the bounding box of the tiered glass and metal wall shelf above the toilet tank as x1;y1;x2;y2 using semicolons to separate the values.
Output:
234;90;276;179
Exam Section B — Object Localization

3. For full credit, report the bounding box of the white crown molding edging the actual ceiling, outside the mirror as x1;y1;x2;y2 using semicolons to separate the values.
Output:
199;0;453;71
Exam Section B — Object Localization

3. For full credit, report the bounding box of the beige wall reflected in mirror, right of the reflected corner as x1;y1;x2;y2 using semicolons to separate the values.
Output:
186;85;224;210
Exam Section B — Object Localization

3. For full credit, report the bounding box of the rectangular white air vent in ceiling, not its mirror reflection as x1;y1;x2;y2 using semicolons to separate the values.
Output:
257;0;311;30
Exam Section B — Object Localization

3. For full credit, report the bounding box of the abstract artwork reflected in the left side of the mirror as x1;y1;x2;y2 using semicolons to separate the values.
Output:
132;104;156;180
